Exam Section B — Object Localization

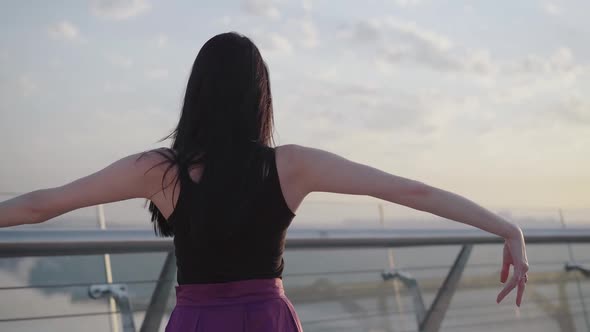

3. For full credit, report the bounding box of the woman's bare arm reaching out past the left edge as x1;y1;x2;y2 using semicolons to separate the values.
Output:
0;153;164;227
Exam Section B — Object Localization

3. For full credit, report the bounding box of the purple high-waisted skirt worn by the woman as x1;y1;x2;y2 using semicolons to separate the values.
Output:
165;278;303;332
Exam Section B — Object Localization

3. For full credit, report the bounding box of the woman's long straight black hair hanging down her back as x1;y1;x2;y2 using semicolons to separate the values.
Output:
146;32;275;237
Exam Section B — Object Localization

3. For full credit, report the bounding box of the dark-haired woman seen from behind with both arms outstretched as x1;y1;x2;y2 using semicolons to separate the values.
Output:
0;33;528;332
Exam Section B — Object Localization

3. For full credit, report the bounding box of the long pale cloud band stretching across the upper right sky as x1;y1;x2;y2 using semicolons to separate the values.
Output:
350;17;580;78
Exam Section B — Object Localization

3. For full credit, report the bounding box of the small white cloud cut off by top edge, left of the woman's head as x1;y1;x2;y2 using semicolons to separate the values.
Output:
91;0;152;20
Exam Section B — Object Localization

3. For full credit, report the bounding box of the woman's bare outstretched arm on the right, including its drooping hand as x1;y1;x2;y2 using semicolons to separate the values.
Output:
292;144;528;305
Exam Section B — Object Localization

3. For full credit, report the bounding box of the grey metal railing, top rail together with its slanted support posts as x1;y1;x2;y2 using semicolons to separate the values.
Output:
0;228;590;332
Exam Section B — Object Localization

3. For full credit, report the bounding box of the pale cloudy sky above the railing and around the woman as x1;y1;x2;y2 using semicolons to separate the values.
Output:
0;0;590;227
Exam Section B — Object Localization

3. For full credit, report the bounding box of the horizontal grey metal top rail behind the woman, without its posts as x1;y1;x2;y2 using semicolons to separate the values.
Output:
0;228;590;257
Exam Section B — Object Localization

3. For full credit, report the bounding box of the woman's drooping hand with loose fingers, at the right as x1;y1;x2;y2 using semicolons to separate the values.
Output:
496;226;529;307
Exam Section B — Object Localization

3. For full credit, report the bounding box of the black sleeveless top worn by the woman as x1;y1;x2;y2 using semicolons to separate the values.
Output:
168;147;295;285
